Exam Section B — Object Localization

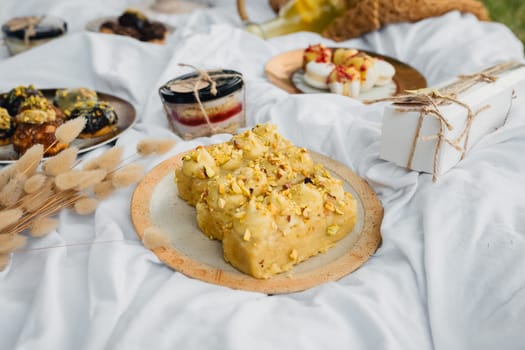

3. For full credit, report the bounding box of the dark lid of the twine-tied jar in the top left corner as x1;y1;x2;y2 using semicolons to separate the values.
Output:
2;16;67;40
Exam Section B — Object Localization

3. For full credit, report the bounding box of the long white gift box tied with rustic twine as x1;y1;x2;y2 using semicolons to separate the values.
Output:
380;62;525;179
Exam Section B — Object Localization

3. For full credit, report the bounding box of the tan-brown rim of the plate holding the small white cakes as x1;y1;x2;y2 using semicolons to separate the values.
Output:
264;49;427;100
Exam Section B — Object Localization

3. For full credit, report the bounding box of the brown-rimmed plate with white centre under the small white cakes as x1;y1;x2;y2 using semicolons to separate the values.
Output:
265;49;427;100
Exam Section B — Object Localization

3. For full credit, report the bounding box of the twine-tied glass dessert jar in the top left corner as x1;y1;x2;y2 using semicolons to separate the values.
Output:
2;16;67;55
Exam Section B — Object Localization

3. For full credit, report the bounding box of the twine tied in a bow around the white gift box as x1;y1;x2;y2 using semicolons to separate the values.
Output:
366;61;524;182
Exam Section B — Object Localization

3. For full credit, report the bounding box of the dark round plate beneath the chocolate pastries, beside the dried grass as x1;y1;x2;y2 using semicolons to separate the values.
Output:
0;89;136;164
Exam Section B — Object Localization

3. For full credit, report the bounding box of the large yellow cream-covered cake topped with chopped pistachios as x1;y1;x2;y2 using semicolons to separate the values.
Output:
175;124;357;279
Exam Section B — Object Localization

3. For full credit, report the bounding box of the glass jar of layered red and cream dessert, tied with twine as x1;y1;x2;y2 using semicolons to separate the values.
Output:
159;70;246;140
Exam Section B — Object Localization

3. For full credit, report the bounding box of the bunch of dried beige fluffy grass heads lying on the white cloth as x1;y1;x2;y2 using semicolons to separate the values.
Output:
0;133;175;271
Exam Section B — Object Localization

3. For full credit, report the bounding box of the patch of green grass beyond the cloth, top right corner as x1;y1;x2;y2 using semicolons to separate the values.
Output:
482;0;525;43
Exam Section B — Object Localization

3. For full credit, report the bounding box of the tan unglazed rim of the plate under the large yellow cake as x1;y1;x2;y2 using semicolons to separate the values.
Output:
131;151;383;294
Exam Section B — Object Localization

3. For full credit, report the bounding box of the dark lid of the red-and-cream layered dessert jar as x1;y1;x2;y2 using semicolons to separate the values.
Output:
159;69;243;103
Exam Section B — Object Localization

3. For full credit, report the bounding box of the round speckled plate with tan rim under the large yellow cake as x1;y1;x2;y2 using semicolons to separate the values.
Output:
131;152;383;294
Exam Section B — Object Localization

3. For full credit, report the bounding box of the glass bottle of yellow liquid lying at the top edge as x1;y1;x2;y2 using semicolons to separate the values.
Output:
245;0;345;39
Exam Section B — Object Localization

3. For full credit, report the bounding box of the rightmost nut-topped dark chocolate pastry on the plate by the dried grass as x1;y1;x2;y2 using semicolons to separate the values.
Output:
69;101;118;138
